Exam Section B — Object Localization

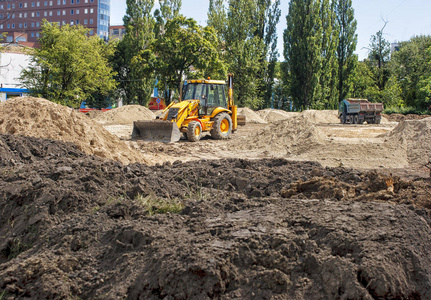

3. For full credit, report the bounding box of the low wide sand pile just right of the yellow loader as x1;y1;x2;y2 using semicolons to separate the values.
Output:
233;115;326;154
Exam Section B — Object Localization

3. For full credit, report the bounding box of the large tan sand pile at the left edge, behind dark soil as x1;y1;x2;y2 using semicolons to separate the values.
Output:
0;97;147;164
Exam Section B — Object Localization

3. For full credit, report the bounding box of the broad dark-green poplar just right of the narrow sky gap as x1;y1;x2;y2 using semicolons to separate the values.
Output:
284;0;322;109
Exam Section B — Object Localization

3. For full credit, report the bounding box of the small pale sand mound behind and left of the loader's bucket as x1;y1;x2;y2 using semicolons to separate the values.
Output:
90;105;156;125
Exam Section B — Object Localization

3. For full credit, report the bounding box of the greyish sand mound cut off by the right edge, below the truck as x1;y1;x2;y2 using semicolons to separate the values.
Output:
386;118;431;164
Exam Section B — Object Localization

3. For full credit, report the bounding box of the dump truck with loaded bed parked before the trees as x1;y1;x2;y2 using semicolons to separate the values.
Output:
338;98;383;124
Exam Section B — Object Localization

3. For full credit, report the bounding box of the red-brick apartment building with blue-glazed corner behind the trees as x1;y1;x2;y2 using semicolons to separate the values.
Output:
0;0;110;43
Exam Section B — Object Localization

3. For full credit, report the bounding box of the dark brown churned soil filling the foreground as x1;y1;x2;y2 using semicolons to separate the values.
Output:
0;136;431;299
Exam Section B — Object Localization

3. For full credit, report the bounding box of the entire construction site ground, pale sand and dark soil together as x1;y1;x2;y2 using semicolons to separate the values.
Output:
0;98;431;299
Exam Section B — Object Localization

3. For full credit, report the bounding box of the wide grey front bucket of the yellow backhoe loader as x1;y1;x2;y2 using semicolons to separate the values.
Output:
132;120;181;143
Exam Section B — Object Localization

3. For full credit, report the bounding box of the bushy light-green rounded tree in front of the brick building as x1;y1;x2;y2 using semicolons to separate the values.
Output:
20;20;116;107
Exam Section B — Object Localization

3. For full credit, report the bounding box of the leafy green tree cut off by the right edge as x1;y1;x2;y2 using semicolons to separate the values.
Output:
391;36;431;108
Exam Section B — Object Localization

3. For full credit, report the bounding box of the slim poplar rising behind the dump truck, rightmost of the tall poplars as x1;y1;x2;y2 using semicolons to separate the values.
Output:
334;0;358;101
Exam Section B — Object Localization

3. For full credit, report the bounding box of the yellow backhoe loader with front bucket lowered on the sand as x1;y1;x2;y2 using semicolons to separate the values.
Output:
132;74;238;143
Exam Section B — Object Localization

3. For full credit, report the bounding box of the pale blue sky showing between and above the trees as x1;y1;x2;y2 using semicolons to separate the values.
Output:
111;0;431;61
